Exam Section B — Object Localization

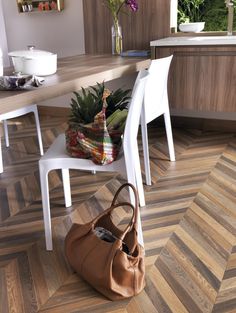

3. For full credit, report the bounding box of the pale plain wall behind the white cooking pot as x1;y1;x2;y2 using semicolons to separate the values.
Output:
2;0;84;57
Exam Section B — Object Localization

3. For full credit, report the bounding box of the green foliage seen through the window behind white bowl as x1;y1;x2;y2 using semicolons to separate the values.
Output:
178;0;236;31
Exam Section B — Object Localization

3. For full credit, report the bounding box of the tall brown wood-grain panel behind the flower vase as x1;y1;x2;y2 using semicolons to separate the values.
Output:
83;0;170;53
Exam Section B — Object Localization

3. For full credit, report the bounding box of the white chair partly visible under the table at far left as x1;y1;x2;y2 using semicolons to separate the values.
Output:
0;104;43;173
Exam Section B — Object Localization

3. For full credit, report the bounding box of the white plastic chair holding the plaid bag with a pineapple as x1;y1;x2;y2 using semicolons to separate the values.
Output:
39;74;147;250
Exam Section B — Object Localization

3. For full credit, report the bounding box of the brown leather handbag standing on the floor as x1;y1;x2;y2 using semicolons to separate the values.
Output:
65;183;145;300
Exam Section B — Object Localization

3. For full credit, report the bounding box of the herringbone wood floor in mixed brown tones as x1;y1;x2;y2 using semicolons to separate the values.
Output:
0;113;236;313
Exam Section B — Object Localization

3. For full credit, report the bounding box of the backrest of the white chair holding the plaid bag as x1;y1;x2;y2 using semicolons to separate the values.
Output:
123;71;149;151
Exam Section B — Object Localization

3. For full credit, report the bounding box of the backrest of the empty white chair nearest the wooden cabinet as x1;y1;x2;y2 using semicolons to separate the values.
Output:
144;55;173;123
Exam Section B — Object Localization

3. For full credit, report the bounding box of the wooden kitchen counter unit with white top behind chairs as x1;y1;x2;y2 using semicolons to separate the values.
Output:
151;36;236;120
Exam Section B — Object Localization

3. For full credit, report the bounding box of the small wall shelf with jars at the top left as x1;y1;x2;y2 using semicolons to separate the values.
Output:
16;0;64;13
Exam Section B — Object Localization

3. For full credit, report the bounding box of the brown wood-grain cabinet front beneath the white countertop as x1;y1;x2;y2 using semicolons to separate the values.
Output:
152;46;236;112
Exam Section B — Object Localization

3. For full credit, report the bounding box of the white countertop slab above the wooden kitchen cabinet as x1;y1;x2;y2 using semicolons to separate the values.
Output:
150;36;236;47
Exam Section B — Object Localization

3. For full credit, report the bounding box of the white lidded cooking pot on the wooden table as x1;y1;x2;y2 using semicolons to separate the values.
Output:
8;46;57;76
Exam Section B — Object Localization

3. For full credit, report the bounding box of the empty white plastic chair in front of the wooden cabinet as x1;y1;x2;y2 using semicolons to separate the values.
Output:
140;56;175;185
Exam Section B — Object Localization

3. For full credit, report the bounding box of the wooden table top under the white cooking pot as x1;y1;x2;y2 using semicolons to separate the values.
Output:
0;55;150;114
